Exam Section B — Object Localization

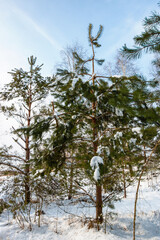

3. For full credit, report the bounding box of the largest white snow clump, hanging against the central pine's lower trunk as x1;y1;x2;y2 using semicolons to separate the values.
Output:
90;156;103;181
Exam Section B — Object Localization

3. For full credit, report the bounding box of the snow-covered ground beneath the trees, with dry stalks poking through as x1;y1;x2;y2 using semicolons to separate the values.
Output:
0;175;160;240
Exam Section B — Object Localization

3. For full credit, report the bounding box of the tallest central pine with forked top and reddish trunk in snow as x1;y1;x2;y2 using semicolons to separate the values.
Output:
29;24;158;226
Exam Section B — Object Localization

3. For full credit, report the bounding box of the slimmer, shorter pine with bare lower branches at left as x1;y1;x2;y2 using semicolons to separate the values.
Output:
0;56;50;204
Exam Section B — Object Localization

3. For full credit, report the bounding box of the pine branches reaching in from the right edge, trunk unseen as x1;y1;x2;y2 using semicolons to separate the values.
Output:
122;0;160;176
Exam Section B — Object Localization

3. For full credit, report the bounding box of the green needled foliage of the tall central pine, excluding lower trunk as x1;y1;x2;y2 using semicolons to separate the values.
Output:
43;25;159;199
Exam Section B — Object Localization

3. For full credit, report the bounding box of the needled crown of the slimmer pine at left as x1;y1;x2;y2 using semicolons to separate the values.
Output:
0;56;51;117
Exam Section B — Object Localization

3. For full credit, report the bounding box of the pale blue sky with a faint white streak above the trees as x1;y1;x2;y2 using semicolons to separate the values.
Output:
0;0;158;85
